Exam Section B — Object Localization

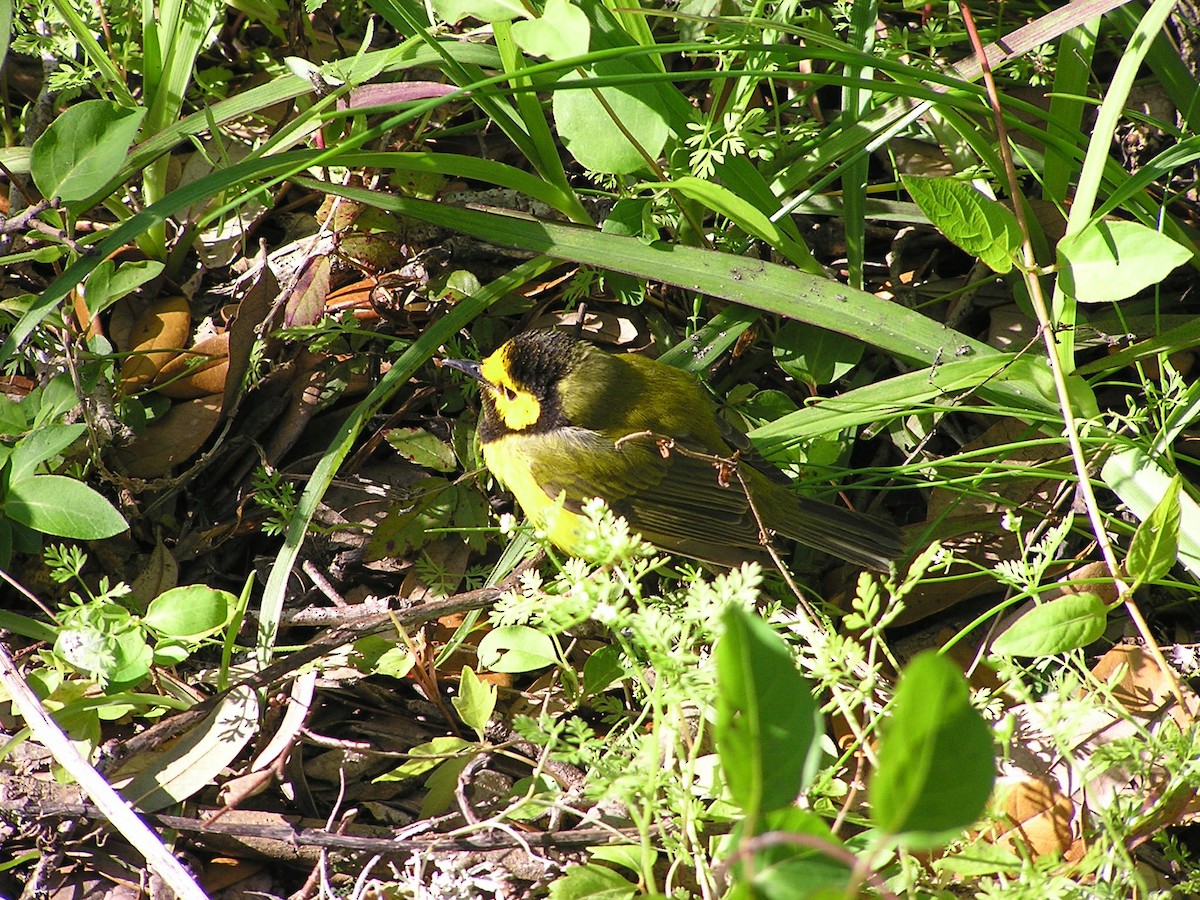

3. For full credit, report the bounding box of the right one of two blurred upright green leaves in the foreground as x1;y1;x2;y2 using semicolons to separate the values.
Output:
868;652;996;847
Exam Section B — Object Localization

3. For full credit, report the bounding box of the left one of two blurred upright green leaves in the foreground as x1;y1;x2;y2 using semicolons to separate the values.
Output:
714;606;822;816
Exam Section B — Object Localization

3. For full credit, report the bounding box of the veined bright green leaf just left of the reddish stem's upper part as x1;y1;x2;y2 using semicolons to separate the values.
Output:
900;175;1021;275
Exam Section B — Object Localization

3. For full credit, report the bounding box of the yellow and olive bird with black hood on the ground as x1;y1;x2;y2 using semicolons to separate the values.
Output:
442;330;904;571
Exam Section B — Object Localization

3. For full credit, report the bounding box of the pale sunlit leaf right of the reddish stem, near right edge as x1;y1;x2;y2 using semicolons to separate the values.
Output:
1058;221;1192;304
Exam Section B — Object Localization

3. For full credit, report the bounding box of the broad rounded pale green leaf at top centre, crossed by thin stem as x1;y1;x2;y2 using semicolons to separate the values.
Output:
552;60;668;175
